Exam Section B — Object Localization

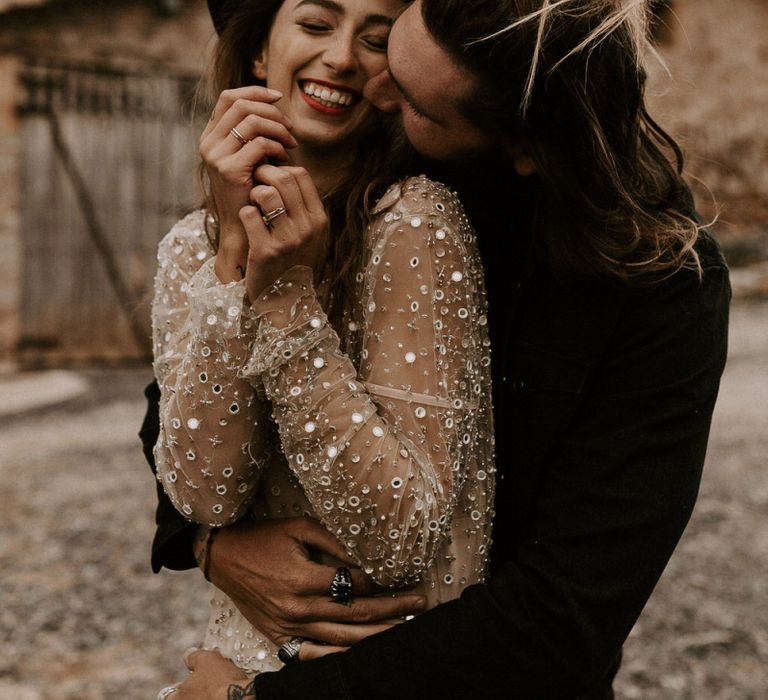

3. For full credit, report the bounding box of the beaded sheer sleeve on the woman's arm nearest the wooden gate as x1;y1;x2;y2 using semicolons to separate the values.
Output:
152;212;269;526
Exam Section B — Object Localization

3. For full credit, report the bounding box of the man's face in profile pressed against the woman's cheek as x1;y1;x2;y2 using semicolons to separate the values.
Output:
364;0;492;160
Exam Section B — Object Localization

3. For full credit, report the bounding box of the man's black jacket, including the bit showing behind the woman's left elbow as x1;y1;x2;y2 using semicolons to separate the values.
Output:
142;178;730;700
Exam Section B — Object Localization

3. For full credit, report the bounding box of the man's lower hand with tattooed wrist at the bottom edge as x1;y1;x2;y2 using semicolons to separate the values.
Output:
170;651;256;700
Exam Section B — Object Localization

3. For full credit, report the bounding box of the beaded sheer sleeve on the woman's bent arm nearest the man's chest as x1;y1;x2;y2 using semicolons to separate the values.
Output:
243;178;494;586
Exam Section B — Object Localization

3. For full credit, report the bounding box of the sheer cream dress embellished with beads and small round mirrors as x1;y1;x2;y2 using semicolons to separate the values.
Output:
152;177;495;672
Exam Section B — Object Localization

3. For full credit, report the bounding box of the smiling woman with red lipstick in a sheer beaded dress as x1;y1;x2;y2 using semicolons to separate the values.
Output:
153;0;495;694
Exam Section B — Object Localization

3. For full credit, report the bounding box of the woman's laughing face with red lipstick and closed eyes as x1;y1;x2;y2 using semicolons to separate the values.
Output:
253;0;404;147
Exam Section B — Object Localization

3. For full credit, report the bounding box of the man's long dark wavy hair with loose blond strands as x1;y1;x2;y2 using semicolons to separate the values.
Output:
422;0;700;284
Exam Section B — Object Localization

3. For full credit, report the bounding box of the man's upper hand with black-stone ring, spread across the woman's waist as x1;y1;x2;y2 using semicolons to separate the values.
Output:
208;518;426;644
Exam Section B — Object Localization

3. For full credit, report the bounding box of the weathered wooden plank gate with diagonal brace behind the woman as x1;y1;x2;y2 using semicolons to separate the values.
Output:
19;58;204;365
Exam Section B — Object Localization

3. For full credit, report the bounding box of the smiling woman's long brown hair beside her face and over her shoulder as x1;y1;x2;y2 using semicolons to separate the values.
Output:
198;0;413;334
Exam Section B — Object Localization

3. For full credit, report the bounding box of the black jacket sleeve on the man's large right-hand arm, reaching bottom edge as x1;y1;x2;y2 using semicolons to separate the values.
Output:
256;249;730;700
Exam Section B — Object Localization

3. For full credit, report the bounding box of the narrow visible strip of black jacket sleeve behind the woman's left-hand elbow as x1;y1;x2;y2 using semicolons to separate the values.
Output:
139;382;196;573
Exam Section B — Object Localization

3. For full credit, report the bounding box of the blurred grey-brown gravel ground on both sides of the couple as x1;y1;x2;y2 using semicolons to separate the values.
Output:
0;300;768;700
